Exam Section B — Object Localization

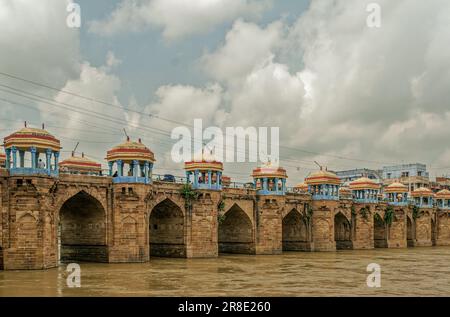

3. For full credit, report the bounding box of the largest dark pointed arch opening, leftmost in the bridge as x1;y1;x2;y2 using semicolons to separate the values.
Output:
58;191;108;262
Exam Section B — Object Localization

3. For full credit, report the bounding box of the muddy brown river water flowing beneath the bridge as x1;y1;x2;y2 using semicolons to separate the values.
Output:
0;247;450;296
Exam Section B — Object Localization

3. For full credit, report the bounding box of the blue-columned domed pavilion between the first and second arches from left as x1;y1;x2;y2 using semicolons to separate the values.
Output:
106;137;155;184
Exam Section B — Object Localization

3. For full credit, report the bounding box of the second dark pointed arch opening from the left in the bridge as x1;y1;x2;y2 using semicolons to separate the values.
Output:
148;198;186;257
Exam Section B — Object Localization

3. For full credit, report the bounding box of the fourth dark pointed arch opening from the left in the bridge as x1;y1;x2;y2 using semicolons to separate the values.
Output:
282;208;310;251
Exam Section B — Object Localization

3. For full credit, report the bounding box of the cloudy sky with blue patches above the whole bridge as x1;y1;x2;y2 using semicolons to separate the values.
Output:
0;0;450;185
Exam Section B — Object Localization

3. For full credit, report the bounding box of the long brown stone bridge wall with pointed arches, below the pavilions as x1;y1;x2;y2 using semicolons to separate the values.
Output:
0;170;450;270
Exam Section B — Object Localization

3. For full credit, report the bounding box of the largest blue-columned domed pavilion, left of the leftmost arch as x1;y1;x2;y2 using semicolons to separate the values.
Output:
4;123;61;176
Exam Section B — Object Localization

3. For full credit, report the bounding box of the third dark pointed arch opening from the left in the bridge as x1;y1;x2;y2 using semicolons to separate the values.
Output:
218;204;255;254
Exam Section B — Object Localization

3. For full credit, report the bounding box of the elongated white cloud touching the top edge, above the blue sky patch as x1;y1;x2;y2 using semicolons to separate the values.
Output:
90;0;271;39
